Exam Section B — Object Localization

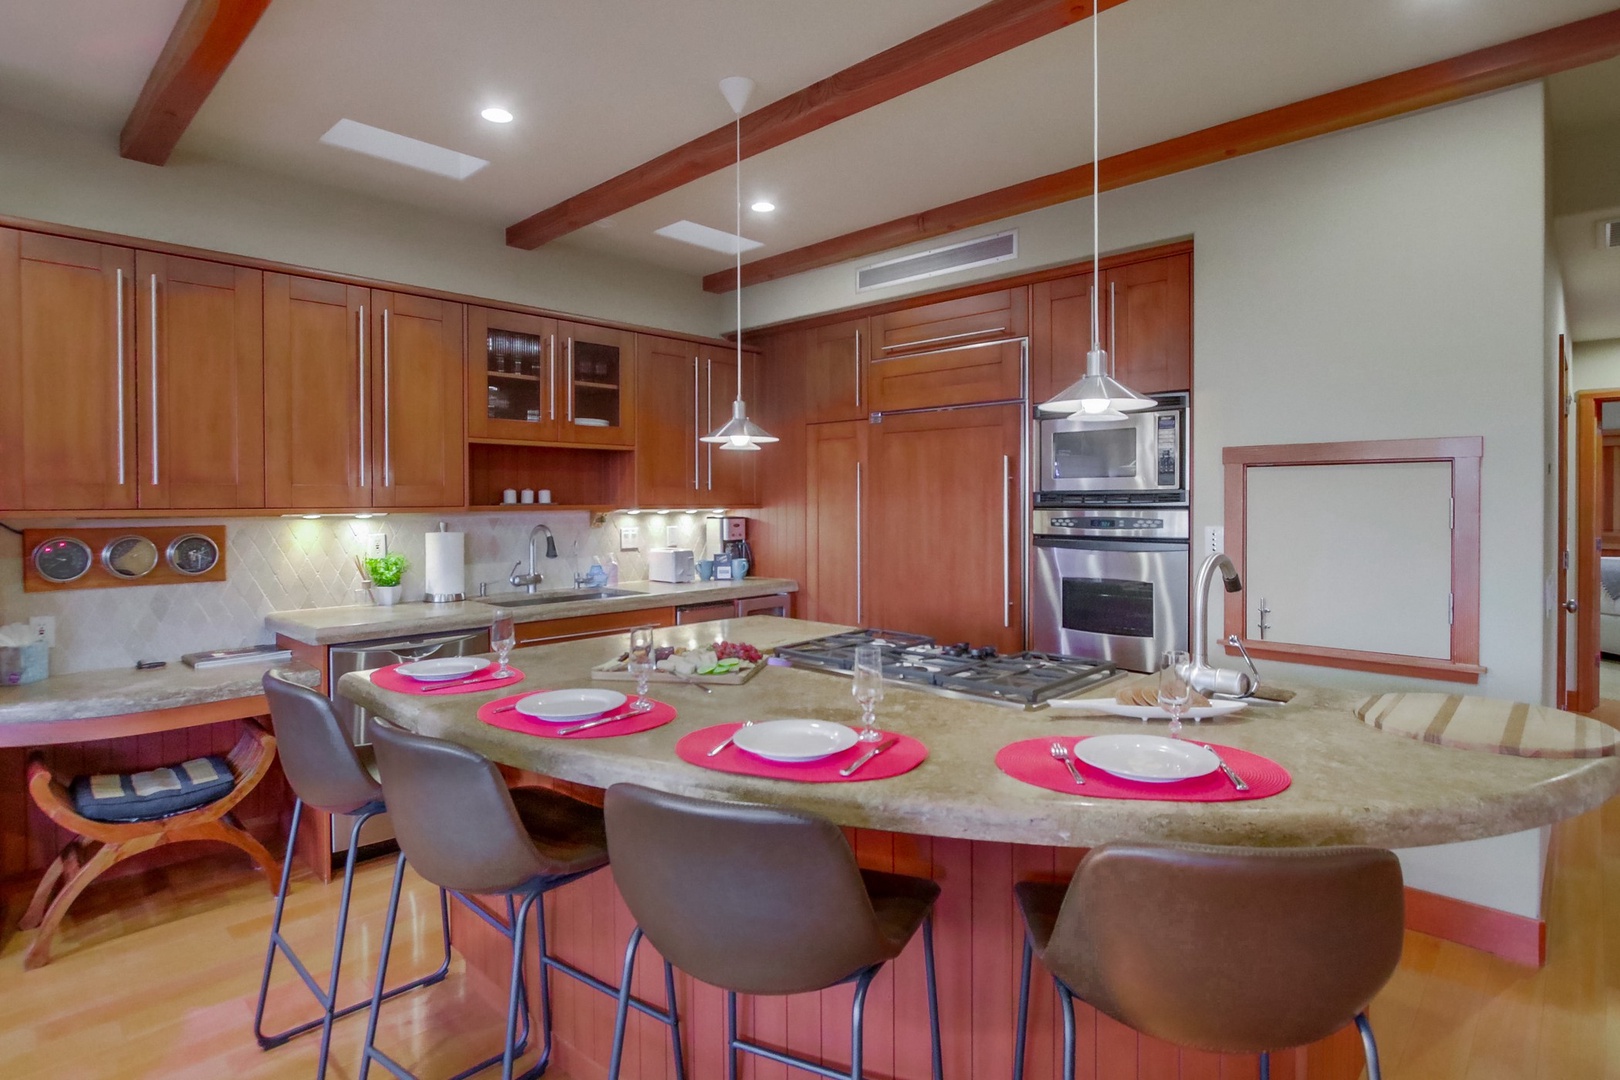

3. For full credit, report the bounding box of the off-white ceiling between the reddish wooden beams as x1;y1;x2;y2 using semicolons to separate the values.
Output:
0;0;1614;283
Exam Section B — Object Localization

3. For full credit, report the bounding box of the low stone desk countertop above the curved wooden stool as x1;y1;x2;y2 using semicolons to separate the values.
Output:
0;664;321;724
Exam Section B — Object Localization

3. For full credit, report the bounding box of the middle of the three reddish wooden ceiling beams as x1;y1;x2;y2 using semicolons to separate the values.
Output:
507;0;1126;249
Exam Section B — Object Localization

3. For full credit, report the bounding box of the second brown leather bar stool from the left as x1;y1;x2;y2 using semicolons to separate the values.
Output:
360;717;685;1080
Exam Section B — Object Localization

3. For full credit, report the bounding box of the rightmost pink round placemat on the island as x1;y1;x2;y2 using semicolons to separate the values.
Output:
996;737;1293;803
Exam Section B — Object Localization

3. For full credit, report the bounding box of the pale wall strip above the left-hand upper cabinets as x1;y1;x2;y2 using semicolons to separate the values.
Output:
0;108;727;335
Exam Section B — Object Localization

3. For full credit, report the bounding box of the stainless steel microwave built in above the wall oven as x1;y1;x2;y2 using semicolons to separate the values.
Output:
1035;393;1187;502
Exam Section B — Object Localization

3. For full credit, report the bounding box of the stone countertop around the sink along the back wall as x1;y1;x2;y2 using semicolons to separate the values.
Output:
264;578;799;644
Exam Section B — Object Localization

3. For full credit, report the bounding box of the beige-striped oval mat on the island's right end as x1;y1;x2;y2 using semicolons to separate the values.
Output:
1356;693;1620;758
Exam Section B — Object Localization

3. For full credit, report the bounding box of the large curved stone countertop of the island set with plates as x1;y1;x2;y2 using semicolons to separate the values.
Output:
340;617;1620;847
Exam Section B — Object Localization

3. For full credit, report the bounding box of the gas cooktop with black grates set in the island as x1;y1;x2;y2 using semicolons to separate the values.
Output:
776;630;1119;709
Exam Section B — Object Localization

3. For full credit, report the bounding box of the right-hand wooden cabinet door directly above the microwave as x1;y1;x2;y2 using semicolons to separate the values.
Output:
1101;254;1192;393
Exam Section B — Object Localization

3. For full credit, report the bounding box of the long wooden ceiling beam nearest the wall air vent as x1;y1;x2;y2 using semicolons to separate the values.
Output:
703;10;1620;293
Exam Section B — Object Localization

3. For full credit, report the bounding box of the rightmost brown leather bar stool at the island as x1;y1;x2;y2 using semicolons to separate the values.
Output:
1013;844;1405;1080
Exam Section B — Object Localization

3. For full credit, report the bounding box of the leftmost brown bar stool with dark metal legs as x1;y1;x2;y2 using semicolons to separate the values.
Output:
253;672;450;1080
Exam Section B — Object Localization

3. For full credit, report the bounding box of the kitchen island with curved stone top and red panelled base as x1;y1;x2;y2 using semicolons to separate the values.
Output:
340;619;1620;1080
